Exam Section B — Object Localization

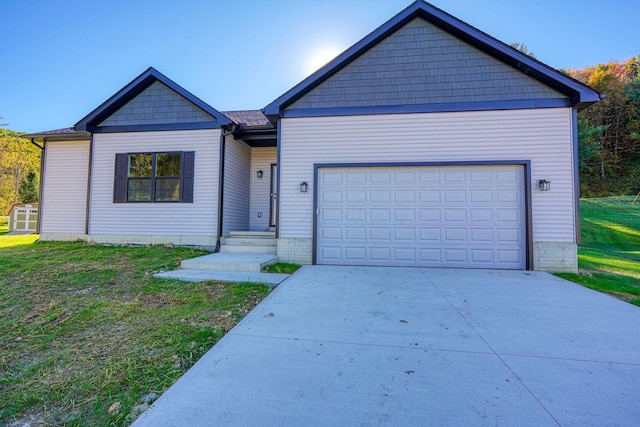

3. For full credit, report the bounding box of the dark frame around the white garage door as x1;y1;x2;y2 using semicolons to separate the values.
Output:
311;160;533;270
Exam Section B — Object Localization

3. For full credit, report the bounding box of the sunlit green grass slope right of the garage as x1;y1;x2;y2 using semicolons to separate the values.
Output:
559;196;640;306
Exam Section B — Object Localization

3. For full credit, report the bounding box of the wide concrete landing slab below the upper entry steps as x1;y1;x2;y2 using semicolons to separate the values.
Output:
180;253;278;272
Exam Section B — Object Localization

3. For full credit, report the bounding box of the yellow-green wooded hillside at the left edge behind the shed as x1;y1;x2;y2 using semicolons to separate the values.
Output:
0;128;40;215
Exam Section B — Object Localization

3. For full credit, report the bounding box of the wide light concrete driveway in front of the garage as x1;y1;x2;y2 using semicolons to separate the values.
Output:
135;266;640;427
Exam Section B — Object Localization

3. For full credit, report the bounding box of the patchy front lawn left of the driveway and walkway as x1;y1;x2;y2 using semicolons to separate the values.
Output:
0;239;270;426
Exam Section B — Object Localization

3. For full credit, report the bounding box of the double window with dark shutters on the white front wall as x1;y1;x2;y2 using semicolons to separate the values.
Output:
113;151;194;203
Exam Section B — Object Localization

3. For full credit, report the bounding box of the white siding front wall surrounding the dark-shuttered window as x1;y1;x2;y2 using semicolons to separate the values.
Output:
89;129;220;242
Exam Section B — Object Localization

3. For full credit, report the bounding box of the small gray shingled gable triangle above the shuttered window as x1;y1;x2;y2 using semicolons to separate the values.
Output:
98;81;216;126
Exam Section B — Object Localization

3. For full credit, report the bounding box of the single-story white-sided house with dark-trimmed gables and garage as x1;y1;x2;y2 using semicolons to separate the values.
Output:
30;0;601;271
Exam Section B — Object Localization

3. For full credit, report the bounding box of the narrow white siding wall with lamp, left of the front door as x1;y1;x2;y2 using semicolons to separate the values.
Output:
249;147;276;231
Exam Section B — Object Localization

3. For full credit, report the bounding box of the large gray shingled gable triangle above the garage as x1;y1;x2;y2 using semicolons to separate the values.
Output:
287;18;567;109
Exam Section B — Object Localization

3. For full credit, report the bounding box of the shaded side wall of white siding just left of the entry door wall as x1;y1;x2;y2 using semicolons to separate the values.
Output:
222;136;251;236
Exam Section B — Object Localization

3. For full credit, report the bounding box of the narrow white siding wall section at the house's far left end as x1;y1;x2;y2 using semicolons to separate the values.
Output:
40;141;90;235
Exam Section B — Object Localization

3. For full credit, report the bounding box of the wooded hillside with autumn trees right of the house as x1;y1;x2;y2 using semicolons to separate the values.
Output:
565;55;640;197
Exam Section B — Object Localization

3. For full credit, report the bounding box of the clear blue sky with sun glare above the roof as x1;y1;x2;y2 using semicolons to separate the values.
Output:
0;0;640;132
